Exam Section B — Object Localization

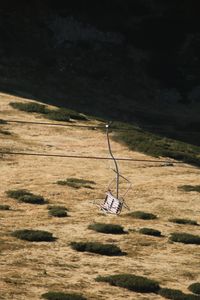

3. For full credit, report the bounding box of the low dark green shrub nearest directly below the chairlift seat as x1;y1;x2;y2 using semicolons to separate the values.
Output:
88;223;126;234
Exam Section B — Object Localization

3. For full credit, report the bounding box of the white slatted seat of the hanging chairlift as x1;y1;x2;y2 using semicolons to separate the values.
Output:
100;191;123;214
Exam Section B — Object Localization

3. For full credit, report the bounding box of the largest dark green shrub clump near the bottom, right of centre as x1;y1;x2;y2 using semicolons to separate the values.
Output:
96;274;160;293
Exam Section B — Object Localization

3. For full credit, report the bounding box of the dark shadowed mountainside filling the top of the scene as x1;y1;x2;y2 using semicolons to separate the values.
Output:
0;0;200;145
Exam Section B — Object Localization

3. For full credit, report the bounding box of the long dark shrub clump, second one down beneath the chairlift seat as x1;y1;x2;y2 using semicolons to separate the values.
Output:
70;242;125;256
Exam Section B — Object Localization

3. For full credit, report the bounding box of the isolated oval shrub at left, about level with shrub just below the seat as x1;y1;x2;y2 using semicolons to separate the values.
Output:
12;229;55;242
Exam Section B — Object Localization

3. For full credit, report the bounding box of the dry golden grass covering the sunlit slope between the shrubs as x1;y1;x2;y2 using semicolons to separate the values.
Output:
0;94;200;300
